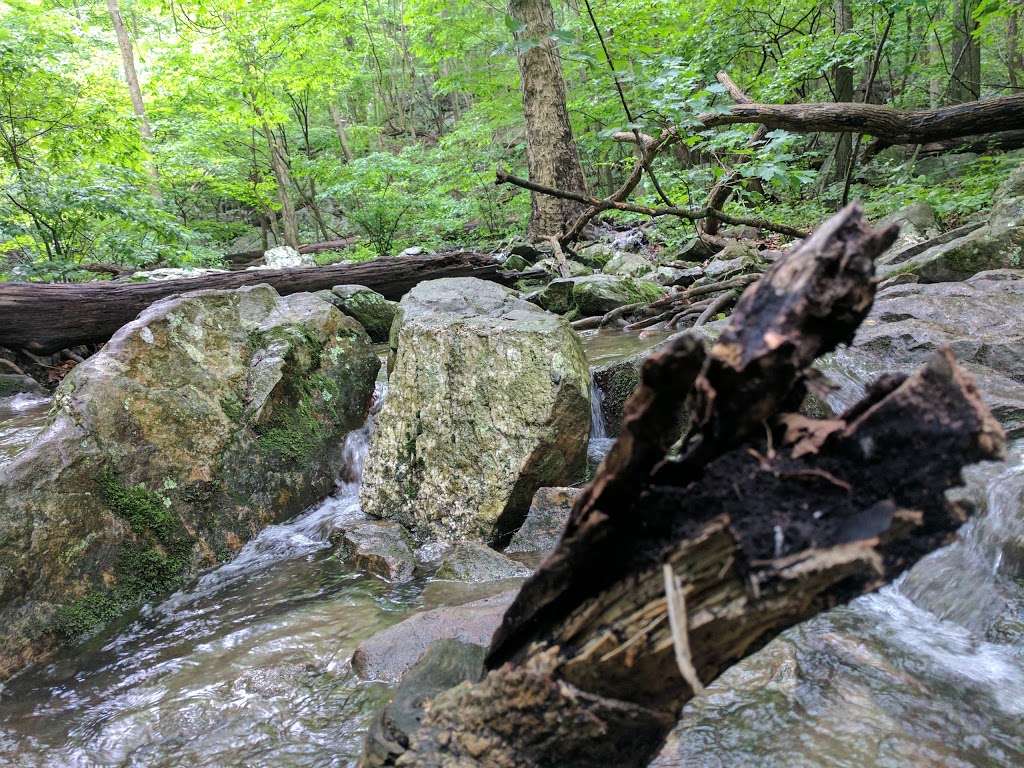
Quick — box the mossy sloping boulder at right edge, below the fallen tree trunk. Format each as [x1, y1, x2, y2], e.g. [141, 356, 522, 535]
[879, 165, 1024, 283]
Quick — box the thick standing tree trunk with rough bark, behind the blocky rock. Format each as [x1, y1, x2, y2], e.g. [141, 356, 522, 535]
[509, 0, 587, 241]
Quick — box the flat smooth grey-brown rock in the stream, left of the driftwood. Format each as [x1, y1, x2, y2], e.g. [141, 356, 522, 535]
[352, 590, 518, 682]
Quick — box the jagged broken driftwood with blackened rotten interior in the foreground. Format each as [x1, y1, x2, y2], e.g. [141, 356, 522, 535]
[372, 206, 1005, 768]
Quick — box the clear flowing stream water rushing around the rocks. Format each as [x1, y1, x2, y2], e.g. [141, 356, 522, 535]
[0, 334, 1024, 768]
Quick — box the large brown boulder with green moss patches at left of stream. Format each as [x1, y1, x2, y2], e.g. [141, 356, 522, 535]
[0, 286, 380, 678]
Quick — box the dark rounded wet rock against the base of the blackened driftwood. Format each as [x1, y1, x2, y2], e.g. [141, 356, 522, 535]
[359, 640, 486, 768]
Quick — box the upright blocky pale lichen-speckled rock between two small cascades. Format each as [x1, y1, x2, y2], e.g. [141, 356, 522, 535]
[360, 278, 590, 541]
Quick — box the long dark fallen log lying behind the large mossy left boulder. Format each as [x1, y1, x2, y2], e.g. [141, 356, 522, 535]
[0, 252, 519, 352]
